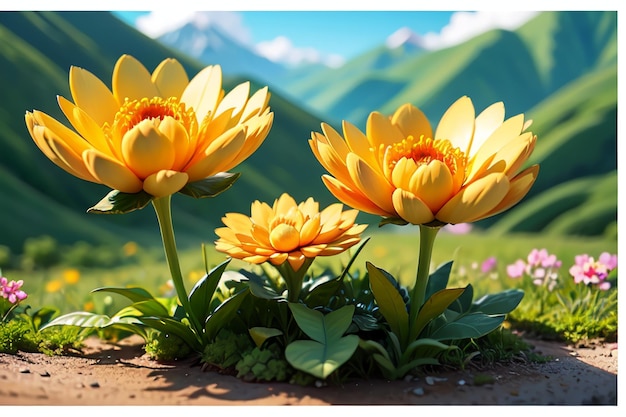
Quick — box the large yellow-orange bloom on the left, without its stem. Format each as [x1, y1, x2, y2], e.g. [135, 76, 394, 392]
[26, 55, 273, 197]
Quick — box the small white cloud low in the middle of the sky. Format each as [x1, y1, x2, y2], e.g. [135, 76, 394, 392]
[254, 36, 344, 67]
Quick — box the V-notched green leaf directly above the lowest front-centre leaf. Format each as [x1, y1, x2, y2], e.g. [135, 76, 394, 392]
[289, 303, 354, 344]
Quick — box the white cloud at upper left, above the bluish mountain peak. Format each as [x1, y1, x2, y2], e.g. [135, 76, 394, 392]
[136, 9, 251, 45]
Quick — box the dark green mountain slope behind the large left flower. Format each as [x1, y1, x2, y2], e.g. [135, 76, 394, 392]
[0, 12, 334, 250]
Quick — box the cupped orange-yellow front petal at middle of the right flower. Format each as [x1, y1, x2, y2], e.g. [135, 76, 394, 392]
[408, 159, 456, 213]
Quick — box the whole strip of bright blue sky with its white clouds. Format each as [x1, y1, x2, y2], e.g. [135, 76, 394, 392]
[113, 7, 533, 66]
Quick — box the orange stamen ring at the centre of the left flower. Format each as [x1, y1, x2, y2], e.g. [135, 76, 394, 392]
[105, 97, 198, 137]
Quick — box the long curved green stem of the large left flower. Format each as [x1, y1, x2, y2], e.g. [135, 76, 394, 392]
[152, 195, 202, 339]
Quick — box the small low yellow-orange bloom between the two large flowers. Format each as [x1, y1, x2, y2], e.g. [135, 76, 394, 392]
[215, 193, 367, 271]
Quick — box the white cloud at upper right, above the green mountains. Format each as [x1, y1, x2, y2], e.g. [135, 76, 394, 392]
[423, 11, 538, 49]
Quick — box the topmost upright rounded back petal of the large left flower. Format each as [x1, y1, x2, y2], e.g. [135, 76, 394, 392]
[113, 55, 159, 104]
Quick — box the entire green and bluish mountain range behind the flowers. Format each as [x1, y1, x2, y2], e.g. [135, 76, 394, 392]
[0, 12, 617, 251]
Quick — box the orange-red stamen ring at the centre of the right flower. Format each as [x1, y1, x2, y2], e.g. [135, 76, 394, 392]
[387, 135, 467, 176]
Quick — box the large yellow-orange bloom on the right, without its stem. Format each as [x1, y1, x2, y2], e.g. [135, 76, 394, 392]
[309, 97, 539, 225]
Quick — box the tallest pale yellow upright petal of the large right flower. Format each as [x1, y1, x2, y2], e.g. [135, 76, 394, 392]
[433, 96, 475, 155]
